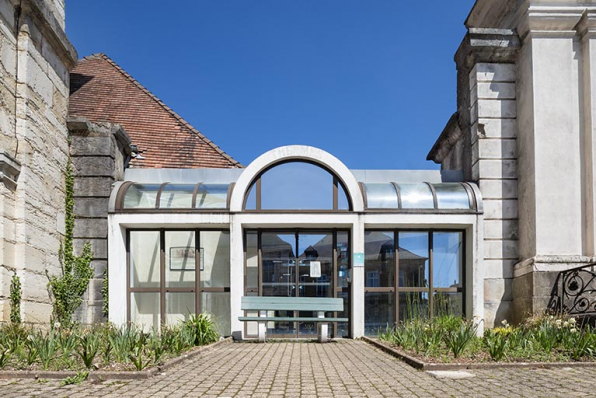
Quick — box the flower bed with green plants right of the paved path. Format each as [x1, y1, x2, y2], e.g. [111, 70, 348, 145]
[379, 316, 596, 364]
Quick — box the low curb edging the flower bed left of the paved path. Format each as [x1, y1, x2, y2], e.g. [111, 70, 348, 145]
[0, 337, 233, 381]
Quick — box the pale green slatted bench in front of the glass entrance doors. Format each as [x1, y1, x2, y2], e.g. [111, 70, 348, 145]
[238, 297, 348, 343]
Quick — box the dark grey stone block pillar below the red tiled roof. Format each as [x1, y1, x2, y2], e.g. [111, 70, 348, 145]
[68, 118, 131, 324]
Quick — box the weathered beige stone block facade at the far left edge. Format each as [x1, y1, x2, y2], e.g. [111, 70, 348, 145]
[0, 0, 76, 322]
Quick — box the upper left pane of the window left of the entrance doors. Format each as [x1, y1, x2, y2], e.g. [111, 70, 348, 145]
[129, 231, 160, 288]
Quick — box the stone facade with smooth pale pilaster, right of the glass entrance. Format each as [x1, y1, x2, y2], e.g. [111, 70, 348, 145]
[429, 0, 596, 325]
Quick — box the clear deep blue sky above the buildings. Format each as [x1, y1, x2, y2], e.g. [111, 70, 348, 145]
[66, 0, 474, 169]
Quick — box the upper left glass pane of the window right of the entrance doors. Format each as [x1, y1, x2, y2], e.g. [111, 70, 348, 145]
[364, 231, 395, 287]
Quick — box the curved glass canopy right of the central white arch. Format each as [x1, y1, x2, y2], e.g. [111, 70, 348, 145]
[363, 182, 475, 210]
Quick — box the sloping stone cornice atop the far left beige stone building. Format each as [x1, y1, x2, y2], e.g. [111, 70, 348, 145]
[11, 0, 78, 69]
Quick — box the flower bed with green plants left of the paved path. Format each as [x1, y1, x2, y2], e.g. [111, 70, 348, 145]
[0, 314, 219, 372]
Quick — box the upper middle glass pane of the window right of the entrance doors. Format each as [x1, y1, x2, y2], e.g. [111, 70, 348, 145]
[398, 232, 429, 287]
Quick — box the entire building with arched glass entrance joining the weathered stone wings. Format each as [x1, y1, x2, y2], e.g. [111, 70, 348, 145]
[0, 0, 596, 332]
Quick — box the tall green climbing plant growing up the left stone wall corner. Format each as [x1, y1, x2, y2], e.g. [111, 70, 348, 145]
[46, 161, 93, 327]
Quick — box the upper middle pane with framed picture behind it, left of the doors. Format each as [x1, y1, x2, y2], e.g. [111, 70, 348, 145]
[165, 231, 196, 287]
